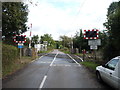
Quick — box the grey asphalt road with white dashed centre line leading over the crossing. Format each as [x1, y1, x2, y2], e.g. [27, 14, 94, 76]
[3, 50, 110, 88]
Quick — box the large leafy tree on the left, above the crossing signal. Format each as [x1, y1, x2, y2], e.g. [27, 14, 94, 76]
[2, 2, 28, 44]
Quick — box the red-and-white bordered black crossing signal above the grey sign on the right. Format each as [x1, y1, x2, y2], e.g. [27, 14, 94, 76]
[84, 29, 99, 39]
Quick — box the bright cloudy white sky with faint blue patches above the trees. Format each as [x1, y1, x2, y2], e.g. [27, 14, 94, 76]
[25, 0, 118, 40]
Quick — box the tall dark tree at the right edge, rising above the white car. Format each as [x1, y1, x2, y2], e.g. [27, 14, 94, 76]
[103, 1, 120, 59]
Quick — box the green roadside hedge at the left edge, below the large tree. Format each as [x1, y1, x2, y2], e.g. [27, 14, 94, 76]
[2, 44, 19, 69]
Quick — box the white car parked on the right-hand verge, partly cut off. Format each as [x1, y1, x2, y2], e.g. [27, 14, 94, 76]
[96, 56, 120, 90]
